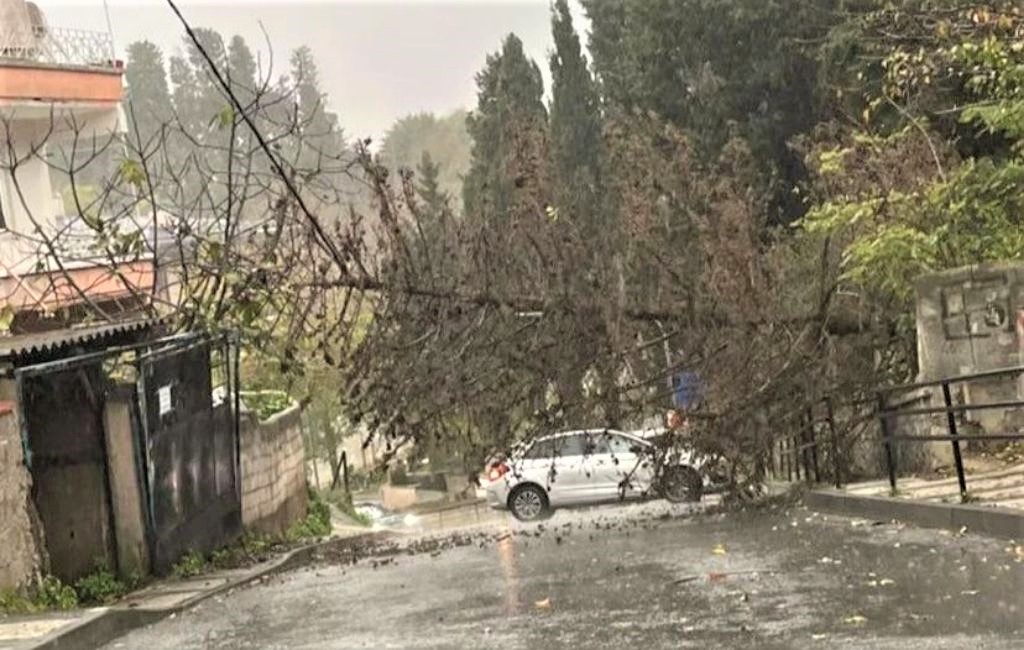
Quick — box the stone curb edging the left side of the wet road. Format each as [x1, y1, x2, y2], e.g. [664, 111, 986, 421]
[32, 532, 388, 650]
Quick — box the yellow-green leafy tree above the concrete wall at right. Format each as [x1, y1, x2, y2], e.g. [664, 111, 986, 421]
[803, 2, 1024, 302]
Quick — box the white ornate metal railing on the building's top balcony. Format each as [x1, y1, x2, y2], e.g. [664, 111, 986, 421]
[0, 25, 117, 68]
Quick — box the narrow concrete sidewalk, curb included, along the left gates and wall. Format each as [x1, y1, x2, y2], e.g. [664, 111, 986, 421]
[0, 528, 388, 650]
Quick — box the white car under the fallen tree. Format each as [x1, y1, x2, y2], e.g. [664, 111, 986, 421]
[486, 429, 705, 521]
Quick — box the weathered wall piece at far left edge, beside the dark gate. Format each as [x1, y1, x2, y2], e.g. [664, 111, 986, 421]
[0, 402, 44, 590]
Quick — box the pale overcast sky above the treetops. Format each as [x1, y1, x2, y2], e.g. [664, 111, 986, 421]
[48, 0, 586, 145]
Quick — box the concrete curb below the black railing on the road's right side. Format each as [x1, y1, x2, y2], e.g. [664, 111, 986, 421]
[804, 490, 1024, 539]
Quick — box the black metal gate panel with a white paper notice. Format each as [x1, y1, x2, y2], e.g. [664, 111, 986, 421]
[136, 337, 242, 572]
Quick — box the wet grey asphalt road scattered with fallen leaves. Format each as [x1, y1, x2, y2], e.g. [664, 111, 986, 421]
[101, 505, 1024, 650]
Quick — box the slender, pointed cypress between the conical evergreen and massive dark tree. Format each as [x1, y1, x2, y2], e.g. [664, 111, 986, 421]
[550, 0, 603, 227]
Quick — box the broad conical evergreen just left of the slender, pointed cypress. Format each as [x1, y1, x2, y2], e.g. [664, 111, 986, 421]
[463, 34, 548, 220]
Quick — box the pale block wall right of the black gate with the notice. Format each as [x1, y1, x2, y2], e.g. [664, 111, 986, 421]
[240, 405, 306, 534]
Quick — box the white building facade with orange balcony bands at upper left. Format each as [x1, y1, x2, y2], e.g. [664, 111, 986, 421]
[0, 0, 154, 333]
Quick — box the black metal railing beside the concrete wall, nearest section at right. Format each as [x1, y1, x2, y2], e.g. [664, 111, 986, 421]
[878, 365, 1024, 503]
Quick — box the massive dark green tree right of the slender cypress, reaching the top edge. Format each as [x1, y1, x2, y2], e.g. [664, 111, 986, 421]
[583, 0, 845, 221]
